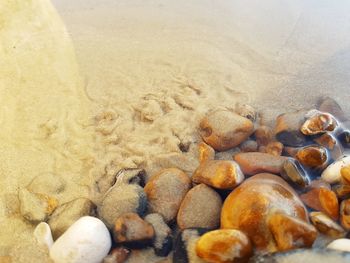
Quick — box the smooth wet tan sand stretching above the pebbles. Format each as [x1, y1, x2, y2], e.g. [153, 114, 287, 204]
[0, 0, 350, 262]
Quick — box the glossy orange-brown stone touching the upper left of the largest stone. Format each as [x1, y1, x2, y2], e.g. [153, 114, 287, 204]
[192, 160, 244, 189]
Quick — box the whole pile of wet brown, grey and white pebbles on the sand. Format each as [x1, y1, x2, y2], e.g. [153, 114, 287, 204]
[28, 98, 350, 263]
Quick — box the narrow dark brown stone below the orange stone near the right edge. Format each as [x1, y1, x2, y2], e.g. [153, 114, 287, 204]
[310, 212, 346, 238]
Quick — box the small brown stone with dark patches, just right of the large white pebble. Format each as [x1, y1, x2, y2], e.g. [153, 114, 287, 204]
[113, 213, 155, 245]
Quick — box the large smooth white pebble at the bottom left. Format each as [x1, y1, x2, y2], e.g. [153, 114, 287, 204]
[50, 216, 111, 263]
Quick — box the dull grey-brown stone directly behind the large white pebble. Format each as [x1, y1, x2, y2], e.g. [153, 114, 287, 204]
[48, 198, 96, 239]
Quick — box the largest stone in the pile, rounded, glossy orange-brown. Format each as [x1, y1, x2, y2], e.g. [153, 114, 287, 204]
[221, 173, 308, 252]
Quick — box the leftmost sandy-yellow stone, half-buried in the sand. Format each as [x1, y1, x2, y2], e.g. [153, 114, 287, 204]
[19, 188, 58, 223]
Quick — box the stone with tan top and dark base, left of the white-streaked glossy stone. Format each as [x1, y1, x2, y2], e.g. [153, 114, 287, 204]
[275, 110, 307, 147]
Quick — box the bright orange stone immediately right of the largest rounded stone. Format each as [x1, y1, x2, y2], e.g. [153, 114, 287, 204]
[300, 187, 339, 220]
